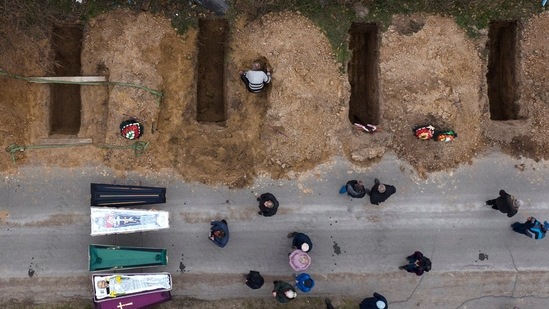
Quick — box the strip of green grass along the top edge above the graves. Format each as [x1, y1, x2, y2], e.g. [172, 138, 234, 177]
[5, 0, 544, 69]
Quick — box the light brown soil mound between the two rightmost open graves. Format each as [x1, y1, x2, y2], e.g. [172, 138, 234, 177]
[380, 16, 485, 176]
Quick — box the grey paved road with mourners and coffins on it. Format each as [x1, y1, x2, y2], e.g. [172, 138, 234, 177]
[0, 153, 549, 309]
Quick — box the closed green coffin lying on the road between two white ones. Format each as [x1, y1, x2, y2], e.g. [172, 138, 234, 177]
[89, 245, 168, 271]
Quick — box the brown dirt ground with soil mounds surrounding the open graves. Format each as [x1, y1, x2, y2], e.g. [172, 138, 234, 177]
[0, 10, 549, 188]
